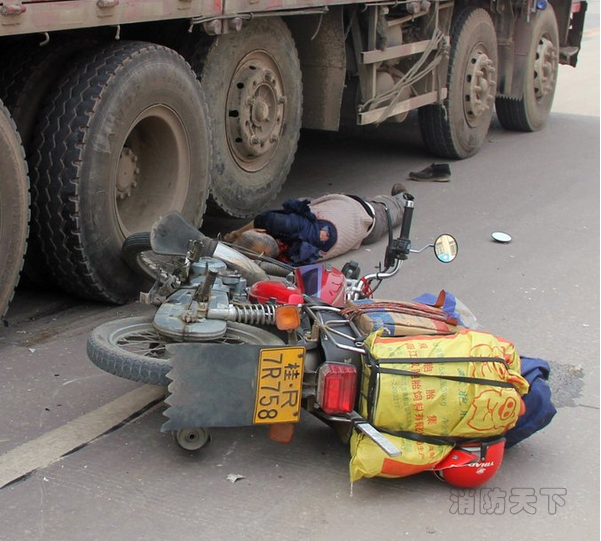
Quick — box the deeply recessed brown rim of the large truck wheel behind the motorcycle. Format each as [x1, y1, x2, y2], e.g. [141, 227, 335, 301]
[115, 105, 191, 237]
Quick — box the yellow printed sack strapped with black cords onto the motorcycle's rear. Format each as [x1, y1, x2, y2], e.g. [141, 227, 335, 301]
[351, 330, 528, 479]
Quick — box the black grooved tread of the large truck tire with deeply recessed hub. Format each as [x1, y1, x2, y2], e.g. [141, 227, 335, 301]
[32, 42, 210, 304]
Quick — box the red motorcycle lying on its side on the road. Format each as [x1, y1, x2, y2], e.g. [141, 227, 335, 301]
[87, 196, 519, 486]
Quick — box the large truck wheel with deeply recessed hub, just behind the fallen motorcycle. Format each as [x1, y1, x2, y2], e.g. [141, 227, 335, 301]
[32, 42, 210, 303]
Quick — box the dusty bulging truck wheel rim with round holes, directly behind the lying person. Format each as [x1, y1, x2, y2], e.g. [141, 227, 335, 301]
[226, 51, 286, 172]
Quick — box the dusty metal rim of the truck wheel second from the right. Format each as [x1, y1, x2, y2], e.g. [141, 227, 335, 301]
[463, 44, 497, 127]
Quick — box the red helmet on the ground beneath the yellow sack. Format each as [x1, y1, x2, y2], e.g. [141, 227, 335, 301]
[434, 438, 505, 488]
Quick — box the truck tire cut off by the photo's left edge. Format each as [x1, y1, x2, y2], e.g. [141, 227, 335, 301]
[0, 102, 29, 317]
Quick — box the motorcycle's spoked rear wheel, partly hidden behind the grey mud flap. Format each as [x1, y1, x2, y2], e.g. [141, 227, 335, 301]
[87, 317, 284, 387]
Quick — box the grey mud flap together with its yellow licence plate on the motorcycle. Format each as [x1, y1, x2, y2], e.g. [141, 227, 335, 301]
[161, 343, 304, 432]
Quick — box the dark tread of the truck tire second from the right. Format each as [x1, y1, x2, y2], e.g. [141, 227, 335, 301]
[418, 6, 494, 160]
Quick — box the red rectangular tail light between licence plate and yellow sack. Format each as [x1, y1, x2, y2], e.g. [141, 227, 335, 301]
[316, 363, 357, 415]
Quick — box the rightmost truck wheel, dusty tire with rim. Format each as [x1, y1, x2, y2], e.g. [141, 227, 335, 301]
[496, 8, 559, 132]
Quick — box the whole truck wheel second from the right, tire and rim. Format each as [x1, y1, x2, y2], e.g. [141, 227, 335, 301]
[419, 7, 497, 159]
